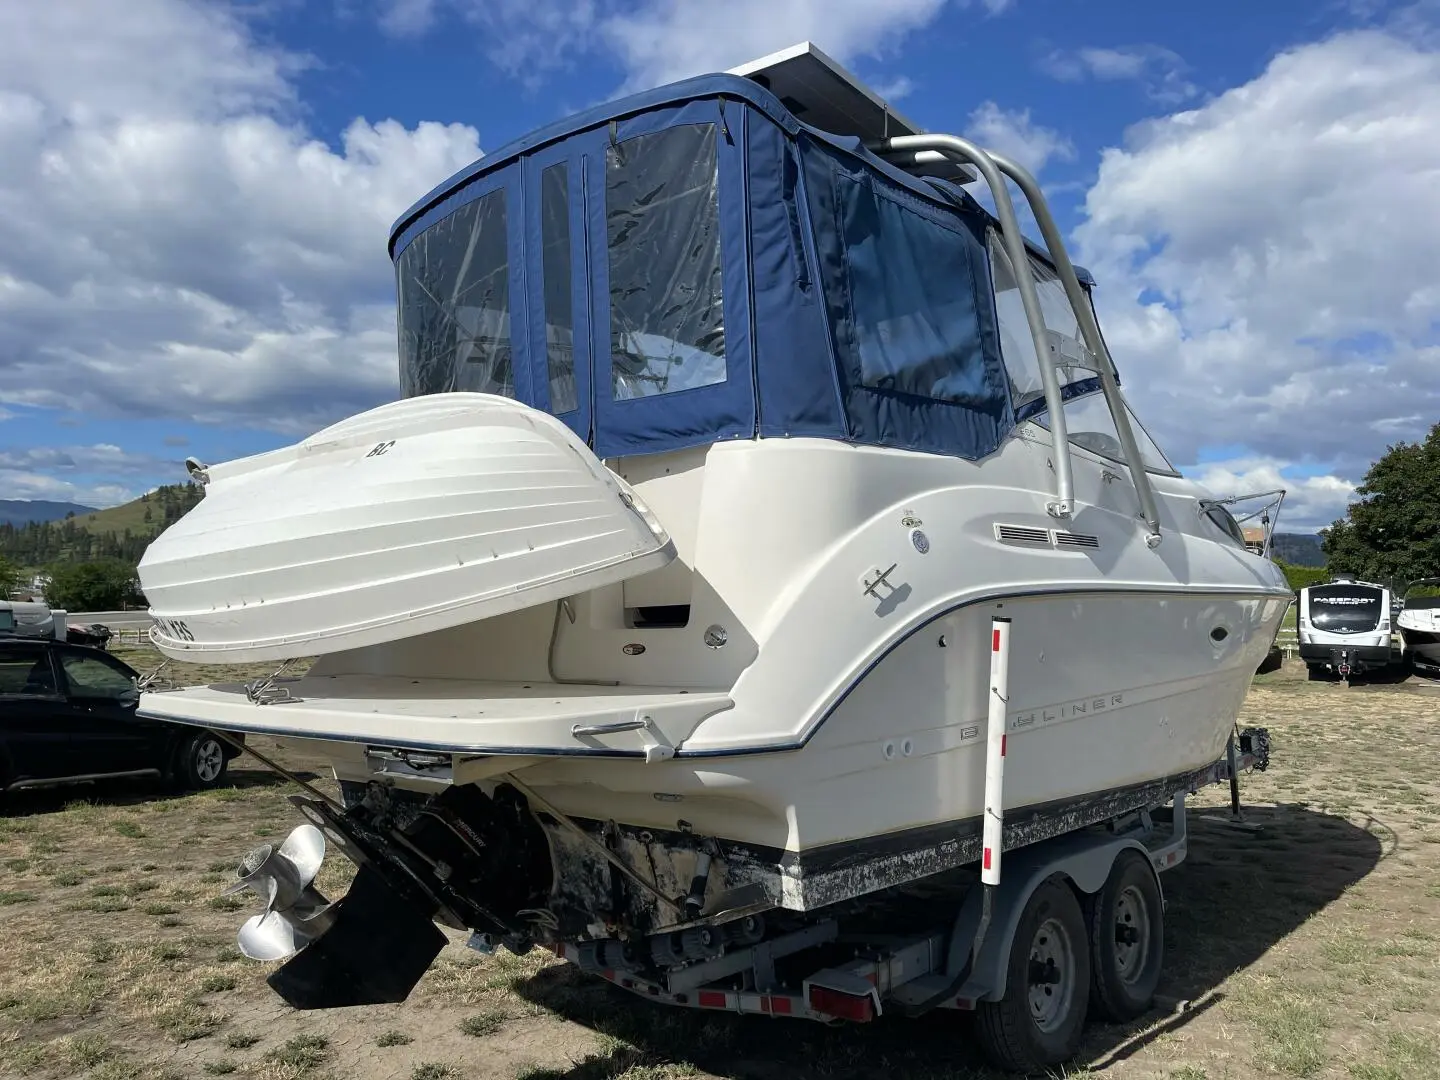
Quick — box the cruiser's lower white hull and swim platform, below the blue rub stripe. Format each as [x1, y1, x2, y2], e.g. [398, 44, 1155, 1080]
[143, 590, 1286, 910]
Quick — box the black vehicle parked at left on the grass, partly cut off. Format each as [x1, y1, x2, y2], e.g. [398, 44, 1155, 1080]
[0, 634, 240, 792]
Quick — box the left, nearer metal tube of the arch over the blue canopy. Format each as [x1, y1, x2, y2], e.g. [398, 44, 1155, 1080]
[867, 135, 1076, 517]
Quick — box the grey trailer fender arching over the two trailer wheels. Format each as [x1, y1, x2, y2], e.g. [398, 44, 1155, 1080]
[946, 835, 1165, 1002]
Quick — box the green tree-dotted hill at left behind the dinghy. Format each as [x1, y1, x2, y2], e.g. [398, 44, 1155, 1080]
[0, 482, 204, 569]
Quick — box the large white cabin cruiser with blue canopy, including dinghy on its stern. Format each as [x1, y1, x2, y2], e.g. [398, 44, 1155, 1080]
[140, 46, 1290, 1059]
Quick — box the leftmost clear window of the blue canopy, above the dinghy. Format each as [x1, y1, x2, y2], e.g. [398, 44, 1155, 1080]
[396, 190, 516, 397]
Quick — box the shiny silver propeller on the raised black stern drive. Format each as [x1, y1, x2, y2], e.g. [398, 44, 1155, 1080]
[223, 825, 336, 960]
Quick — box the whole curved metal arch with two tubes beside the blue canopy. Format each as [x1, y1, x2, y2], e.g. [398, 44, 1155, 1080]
[871, 135, 1161, 547]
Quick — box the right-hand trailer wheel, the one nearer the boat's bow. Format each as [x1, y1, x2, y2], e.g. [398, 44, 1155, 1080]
[1090, 850, 1165, 1024]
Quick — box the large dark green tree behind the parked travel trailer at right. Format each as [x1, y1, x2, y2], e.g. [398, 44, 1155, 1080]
[1320, 423, 1440, 593]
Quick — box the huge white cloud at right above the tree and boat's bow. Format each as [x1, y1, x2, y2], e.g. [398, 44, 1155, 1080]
[1076, 32, 1440, 504]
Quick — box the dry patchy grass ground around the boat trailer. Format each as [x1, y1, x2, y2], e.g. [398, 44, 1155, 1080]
[0, 651, 1440, 1080]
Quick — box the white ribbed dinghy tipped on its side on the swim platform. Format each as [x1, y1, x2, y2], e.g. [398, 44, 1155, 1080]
[144, 393, 675, 664]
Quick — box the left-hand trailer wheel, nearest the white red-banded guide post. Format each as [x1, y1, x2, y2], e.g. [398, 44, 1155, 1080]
[975, 878, 1090, 1073]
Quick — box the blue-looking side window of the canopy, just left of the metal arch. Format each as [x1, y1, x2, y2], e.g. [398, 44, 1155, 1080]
[837, 179, 991, 402]
